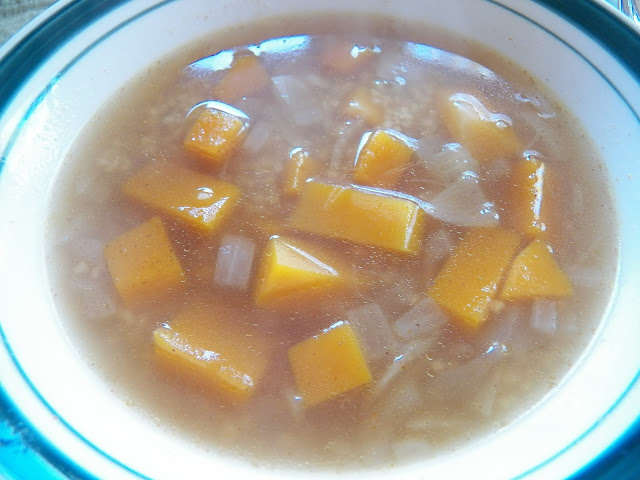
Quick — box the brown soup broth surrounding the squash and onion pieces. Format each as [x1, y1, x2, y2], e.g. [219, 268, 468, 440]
[49, 17, 617, 468]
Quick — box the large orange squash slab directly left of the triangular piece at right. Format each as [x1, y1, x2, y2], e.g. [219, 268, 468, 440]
[428, 228, 520, 328]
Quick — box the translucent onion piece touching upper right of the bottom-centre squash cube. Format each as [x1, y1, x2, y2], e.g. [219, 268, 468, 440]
[347, 302, 398, 361]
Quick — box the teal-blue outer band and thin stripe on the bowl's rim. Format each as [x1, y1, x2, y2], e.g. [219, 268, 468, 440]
[0, 0, 640, 480]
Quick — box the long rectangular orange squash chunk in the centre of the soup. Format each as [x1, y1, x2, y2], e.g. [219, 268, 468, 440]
[290, 181, 426, 254]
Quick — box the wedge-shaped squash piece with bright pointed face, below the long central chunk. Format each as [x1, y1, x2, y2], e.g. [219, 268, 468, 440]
[255, 236, 349, 309]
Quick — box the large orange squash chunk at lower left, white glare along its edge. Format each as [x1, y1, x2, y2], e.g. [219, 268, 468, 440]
[153, 303, 272, 401]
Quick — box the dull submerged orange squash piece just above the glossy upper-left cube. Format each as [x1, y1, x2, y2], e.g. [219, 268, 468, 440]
[213, 52, 271, 102]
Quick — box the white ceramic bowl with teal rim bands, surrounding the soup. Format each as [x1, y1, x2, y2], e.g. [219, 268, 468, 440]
[0, 0, 640, 479]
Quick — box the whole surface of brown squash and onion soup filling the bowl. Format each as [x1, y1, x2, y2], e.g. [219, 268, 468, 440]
[49, 17, 616, 468]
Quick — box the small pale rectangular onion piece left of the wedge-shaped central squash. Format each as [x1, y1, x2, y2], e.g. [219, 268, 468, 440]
[213, 235, 255, 289]
